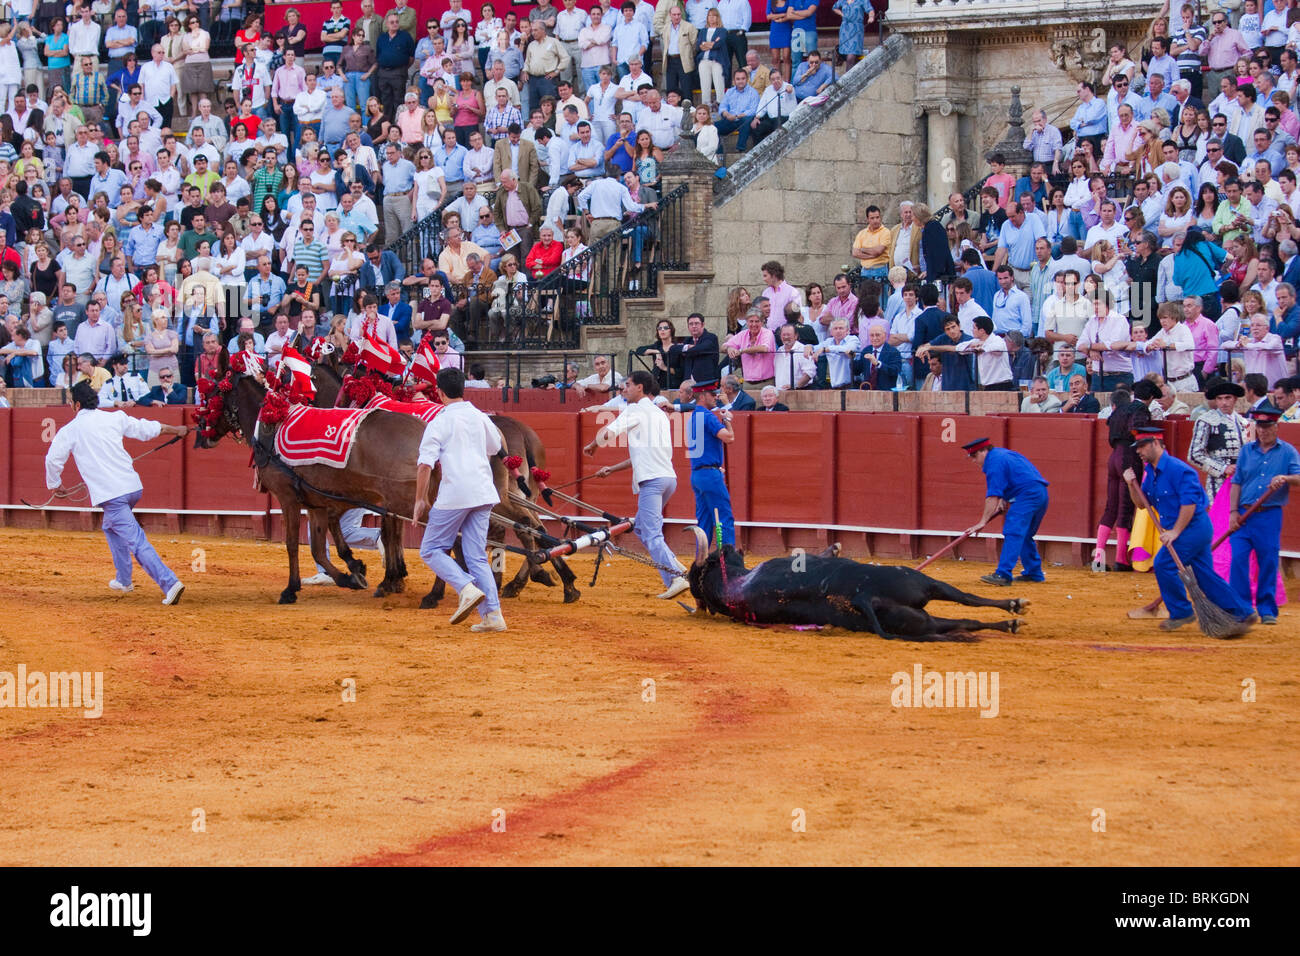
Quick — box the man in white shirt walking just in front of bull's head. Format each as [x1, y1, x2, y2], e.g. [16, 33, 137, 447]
[585, 368, 690, 600]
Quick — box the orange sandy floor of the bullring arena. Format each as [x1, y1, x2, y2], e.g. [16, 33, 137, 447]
[0, 529, 1300, 865]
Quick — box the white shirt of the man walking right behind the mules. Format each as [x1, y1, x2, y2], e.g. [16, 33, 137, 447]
[417, 402, 501, 511]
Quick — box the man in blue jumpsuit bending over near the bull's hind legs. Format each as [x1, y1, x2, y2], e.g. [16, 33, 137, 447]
[962, 438, 1048, 587]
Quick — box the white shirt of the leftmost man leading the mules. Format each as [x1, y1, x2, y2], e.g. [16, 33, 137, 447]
[46, 408, 163, 505]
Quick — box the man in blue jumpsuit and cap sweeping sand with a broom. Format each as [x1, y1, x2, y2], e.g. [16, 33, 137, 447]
[1125, 425, 1258, 637]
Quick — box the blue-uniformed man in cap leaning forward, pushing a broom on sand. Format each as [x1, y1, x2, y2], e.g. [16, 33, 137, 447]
[1123, 425, 1255, 631]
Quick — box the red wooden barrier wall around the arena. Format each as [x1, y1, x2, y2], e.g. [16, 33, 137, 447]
[0, 411, 1300, 561]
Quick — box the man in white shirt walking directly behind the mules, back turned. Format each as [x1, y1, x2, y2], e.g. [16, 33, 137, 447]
[415, 368, 506, 631]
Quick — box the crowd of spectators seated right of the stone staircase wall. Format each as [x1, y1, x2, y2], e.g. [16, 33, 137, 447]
[616, 0, 1300, 420]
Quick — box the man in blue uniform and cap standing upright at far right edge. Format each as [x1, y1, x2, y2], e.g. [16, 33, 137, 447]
[1227, 401, 1300, 624]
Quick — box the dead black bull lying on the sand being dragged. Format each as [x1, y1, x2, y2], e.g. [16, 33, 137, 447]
[688, 527, 1030, 641]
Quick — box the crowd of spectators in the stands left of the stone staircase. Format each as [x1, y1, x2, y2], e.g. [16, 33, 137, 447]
[0, 0, 875, 392]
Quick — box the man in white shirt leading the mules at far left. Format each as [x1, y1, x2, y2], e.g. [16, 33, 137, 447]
[46, 381, 190, 605]
